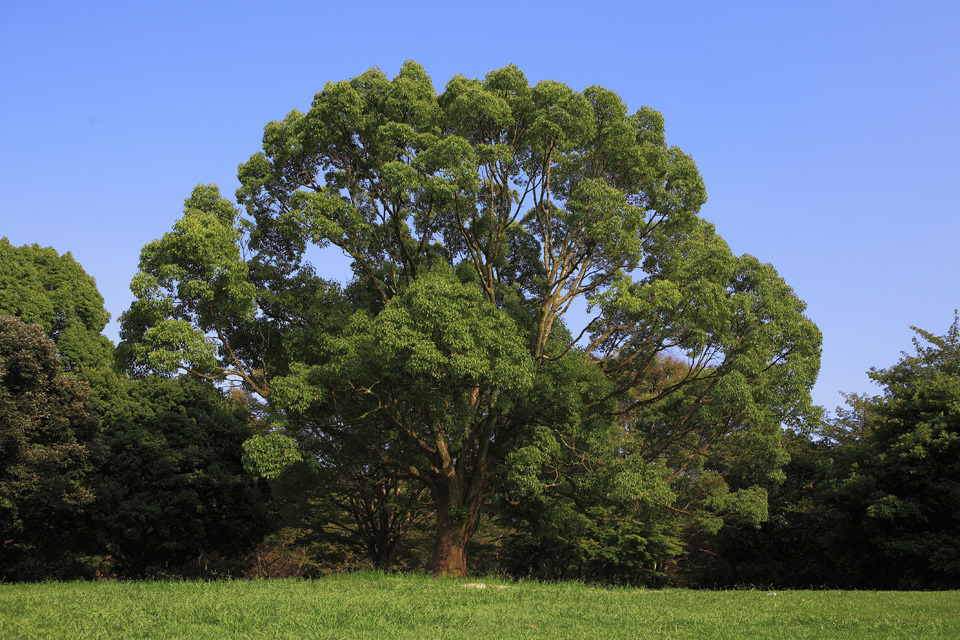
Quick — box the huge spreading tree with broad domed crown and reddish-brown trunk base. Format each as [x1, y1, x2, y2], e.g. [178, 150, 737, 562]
[121, 63, 820, 574]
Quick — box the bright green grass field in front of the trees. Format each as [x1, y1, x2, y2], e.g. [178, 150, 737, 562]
[0, 573, 960, 640]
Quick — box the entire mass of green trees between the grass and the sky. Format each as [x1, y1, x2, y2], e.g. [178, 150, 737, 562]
[0, 63, 960, 589]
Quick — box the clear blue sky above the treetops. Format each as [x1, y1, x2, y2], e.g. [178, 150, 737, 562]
[0, 0, 960, 416]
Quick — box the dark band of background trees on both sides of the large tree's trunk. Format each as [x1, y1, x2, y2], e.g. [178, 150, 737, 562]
[0, 260, 960, 589]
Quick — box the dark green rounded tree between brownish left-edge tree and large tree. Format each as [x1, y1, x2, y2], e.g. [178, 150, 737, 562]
[88, 377, 267, 577]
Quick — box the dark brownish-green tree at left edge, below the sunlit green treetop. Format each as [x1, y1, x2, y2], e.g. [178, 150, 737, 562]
[0, 315, 101, 580]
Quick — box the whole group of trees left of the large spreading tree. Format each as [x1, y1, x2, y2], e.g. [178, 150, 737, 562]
[0, 248, 268, 580]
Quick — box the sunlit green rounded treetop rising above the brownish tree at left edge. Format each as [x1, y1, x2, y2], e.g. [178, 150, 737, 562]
[0, 238, 113, 373]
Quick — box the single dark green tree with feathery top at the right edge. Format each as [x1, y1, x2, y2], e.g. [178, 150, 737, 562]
[828, 317, 960, 588]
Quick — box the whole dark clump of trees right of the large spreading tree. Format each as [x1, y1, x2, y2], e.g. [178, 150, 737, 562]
[703, 319, 960, 589]
